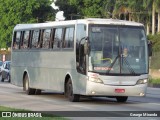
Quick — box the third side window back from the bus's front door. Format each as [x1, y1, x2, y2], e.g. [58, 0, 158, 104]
[42, 29, 51, 49]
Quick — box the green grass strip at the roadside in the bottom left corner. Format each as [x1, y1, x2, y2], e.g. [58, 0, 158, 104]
[0, 106, 68, 120]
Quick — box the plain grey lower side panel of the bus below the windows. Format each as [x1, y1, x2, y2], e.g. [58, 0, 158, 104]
[11, 50, 86, 94]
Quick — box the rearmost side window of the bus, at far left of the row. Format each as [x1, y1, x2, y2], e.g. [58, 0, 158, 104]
[13, 32, 21, 49]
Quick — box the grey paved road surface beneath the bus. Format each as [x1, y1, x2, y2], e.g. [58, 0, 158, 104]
[0, 82, 160, 120]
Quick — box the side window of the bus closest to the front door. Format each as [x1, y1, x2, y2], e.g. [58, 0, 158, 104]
[63, 27, 74, 48]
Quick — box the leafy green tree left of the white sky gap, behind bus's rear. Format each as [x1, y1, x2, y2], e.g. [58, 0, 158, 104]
[0, 0, 55, 48]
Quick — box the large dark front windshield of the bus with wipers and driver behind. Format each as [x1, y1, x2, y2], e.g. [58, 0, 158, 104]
[89, 25, 148, 75]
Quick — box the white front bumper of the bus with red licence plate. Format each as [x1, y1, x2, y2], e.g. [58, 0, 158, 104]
[86, 81, 147, 96]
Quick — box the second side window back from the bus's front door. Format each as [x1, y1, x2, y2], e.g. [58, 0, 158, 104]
[53, 28, 62, 49]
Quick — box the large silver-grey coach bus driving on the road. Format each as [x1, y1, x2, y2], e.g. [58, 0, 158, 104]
[11, 18, 149, 102]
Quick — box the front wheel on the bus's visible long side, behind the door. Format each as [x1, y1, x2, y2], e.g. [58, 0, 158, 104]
[65, 79, 80, 102]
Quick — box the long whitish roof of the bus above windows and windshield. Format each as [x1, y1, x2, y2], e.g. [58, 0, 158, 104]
[14, 18, 143, 30]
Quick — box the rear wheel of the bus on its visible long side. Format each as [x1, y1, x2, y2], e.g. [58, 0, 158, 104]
[24, 75, 36, 95]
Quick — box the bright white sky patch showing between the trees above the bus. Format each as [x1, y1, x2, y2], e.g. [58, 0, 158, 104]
[51, 0, 65, 21]
